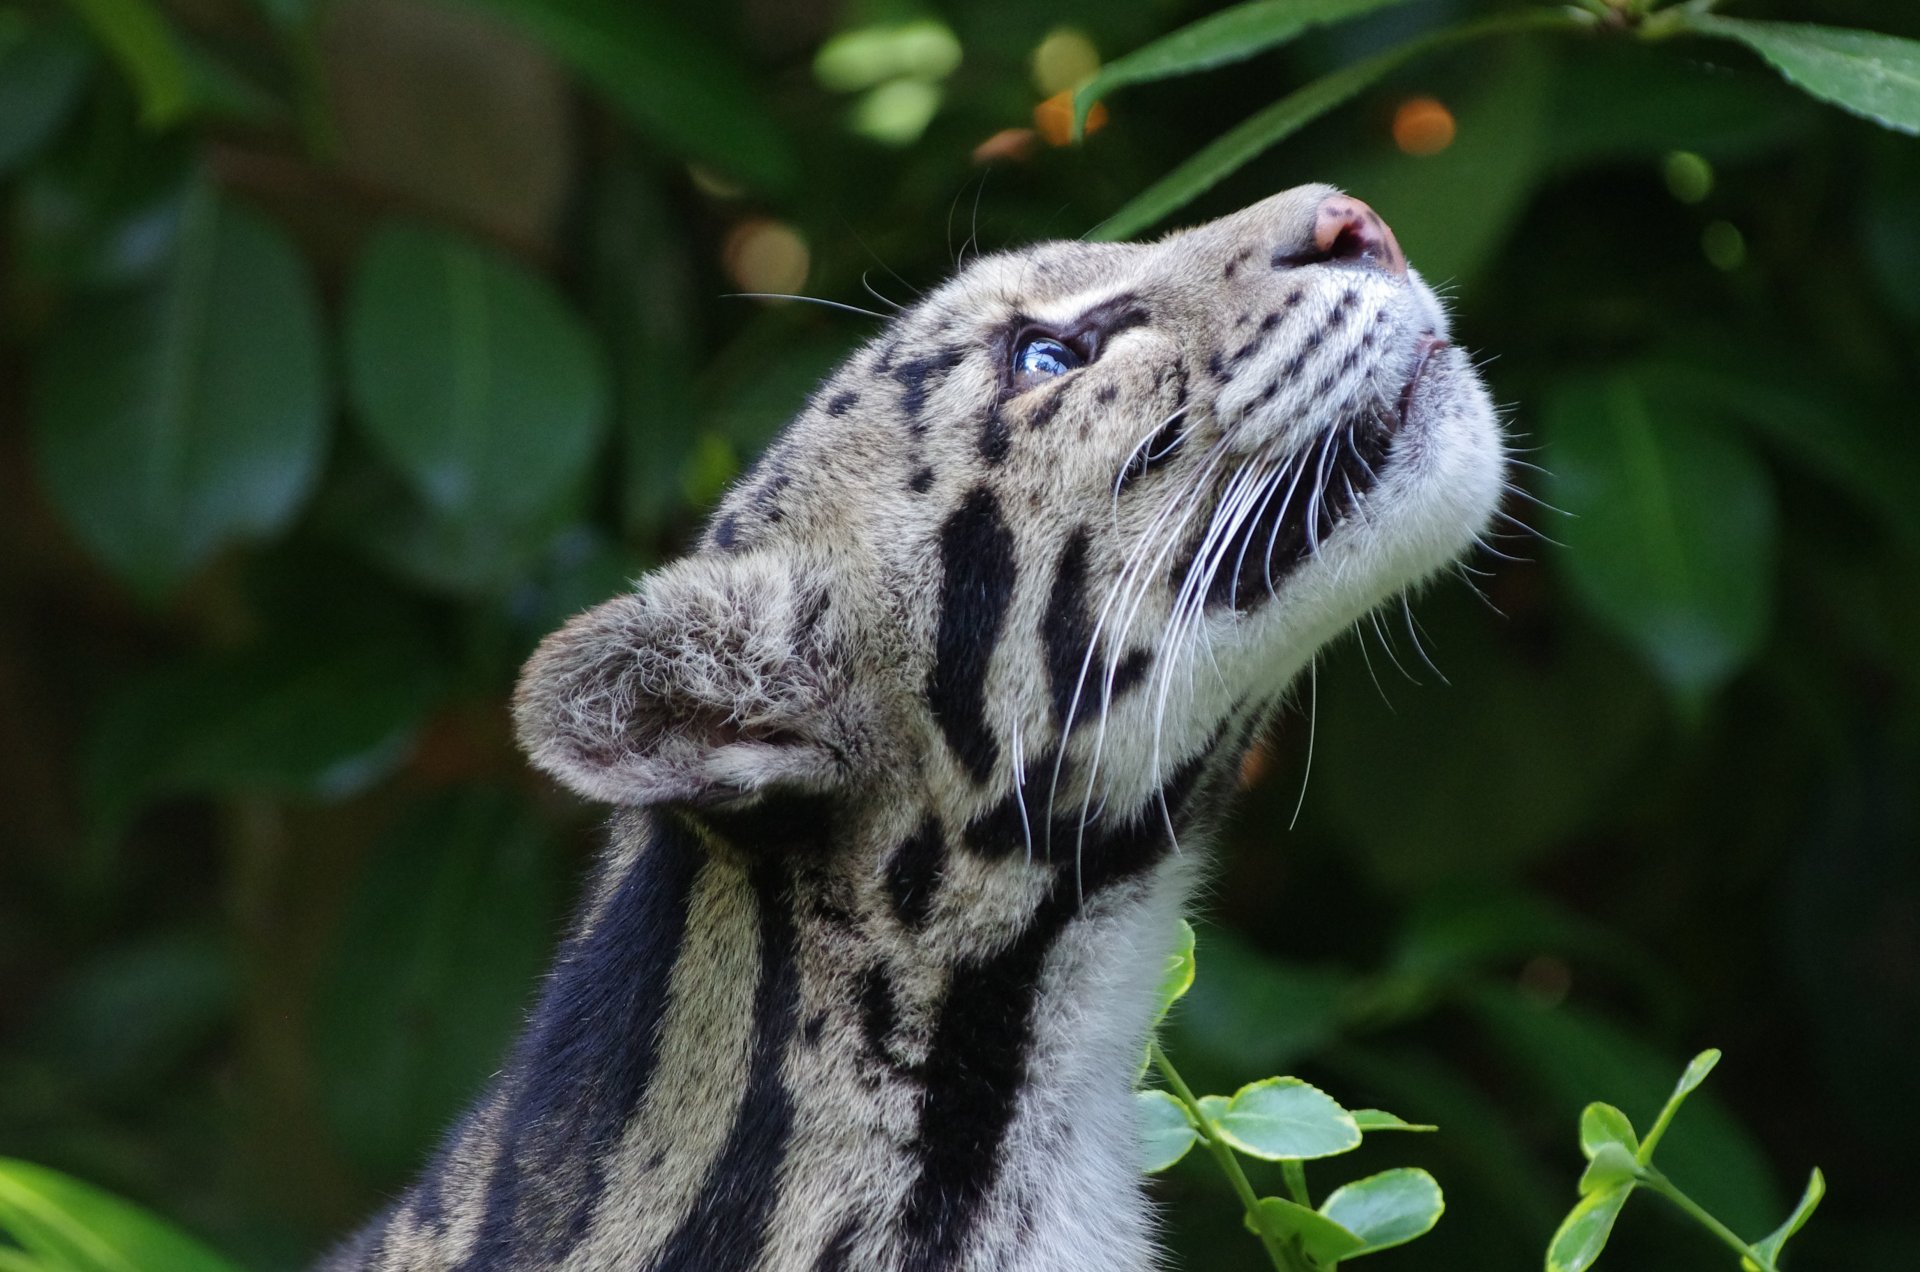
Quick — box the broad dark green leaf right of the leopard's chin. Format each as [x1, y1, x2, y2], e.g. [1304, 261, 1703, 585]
[1544, 375, 1776, 707]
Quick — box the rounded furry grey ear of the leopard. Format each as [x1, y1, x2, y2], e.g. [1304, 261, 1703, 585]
[513, 555, 862, 805]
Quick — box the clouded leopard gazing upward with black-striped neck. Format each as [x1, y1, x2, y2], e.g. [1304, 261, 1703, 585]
[326, 186, 1503, 1272]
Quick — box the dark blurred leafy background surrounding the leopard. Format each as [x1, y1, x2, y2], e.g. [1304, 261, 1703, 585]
[0, 0, 1920, 1272]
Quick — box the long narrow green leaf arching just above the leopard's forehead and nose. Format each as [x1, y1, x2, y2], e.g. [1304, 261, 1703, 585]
[1087, 10, 1565, 240]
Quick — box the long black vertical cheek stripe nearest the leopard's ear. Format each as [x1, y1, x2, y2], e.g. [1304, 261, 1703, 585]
[927, 486, 1016, 782]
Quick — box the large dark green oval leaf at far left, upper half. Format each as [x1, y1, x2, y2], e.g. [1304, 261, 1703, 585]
[33, 186, 330, 598]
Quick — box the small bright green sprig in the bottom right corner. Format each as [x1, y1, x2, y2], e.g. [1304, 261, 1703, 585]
[1546, 1051, 1826, 1272]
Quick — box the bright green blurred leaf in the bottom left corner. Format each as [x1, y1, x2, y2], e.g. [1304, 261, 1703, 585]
[0, 1157, 238, 1272]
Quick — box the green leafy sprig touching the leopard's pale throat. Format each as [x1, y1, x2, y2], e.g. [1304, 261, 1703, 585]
[1135, 922, 1446, 1272]
